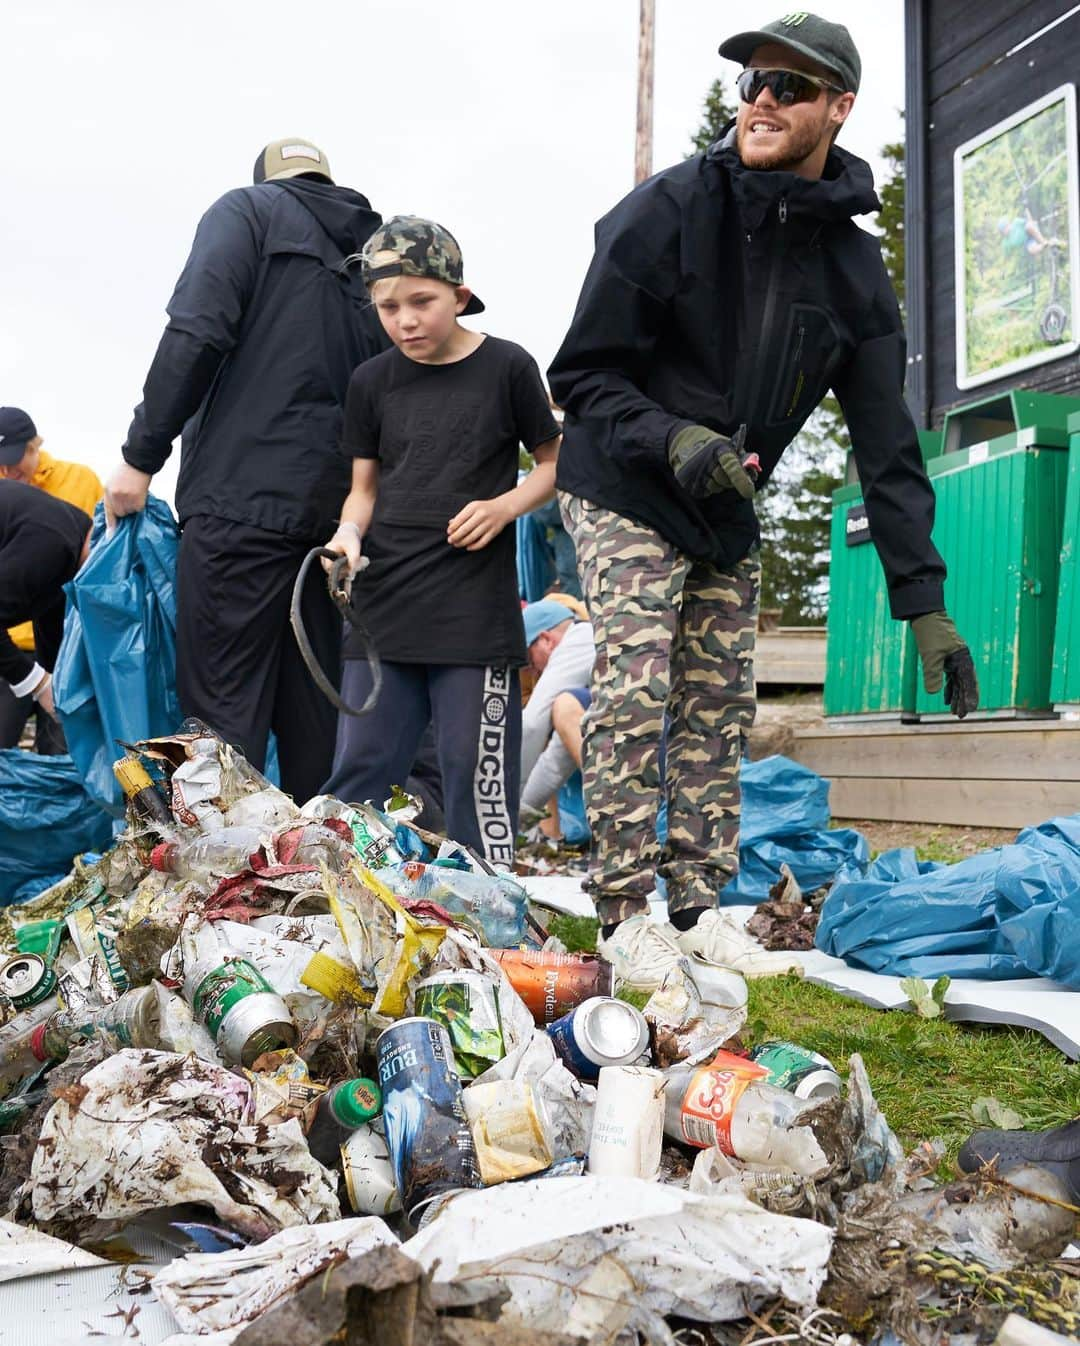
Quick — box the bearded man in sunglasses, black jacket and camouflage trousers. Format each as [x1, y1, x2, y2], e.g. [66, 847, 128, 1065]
[549, 12, 978, 938]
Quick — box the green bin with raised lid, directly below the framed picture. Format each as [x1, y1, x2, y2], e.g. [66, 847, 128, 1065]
[916, 422, 1076, 719]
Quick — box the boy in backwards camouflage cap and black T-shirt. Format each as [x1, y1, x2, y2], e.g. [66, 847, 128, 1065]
[326, 215, 559, 865]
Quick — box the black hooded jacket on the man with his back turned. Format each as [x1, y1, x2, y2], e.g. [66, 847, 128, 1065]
[124, 178, 388, 540]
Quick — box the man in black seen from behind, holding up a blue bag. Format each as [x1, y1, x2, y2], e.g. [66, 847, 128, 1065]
[105, 139, 385, 800]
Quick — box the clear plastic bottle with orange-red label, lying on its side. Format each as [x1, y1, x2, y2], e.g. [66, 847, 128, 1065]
[664, 1051, 828, 1178]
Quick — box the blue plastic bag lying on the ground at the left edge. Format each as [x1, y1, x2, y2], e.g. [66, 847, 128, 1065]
[0, 748, 112, 906]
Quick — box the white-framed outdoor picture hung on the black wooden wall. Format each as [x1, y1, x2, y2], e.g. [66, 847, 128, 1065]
[953, 85, 1080, 388]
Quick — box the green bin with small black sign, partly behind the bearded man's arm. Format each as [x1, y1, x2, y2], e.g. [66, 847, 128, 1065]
[824, 485, 916, 719]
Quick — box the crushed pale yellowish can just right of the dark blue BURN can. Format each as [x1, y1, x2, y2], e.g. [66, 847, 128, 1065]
[465, 1079, 552, 1187]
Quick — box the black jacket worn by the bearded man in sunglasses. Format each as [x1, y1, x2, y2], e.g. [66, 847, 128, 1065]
[549, 133, 945, 618]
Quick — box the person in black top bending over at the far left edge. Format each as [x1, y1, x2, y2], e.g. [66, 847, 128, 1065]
[0, 481, 90, 752]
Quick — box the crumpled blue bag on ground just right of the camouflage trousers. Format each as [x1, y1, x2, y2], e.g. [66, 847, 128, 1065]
[720, 756, 870, 903]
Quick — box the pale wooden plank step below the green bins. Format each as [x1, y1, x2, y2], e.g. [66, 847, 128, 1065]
[792, 720, 1080, 828]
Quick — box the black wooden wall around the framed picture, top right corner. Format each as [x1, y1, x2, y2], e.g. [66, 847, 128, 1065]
[899, 0, 1080, 428]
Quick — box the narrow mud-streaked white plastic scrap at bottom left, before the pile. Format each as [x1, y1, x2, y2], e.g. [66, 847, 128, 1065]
[151, 1215, 397, 1339]
